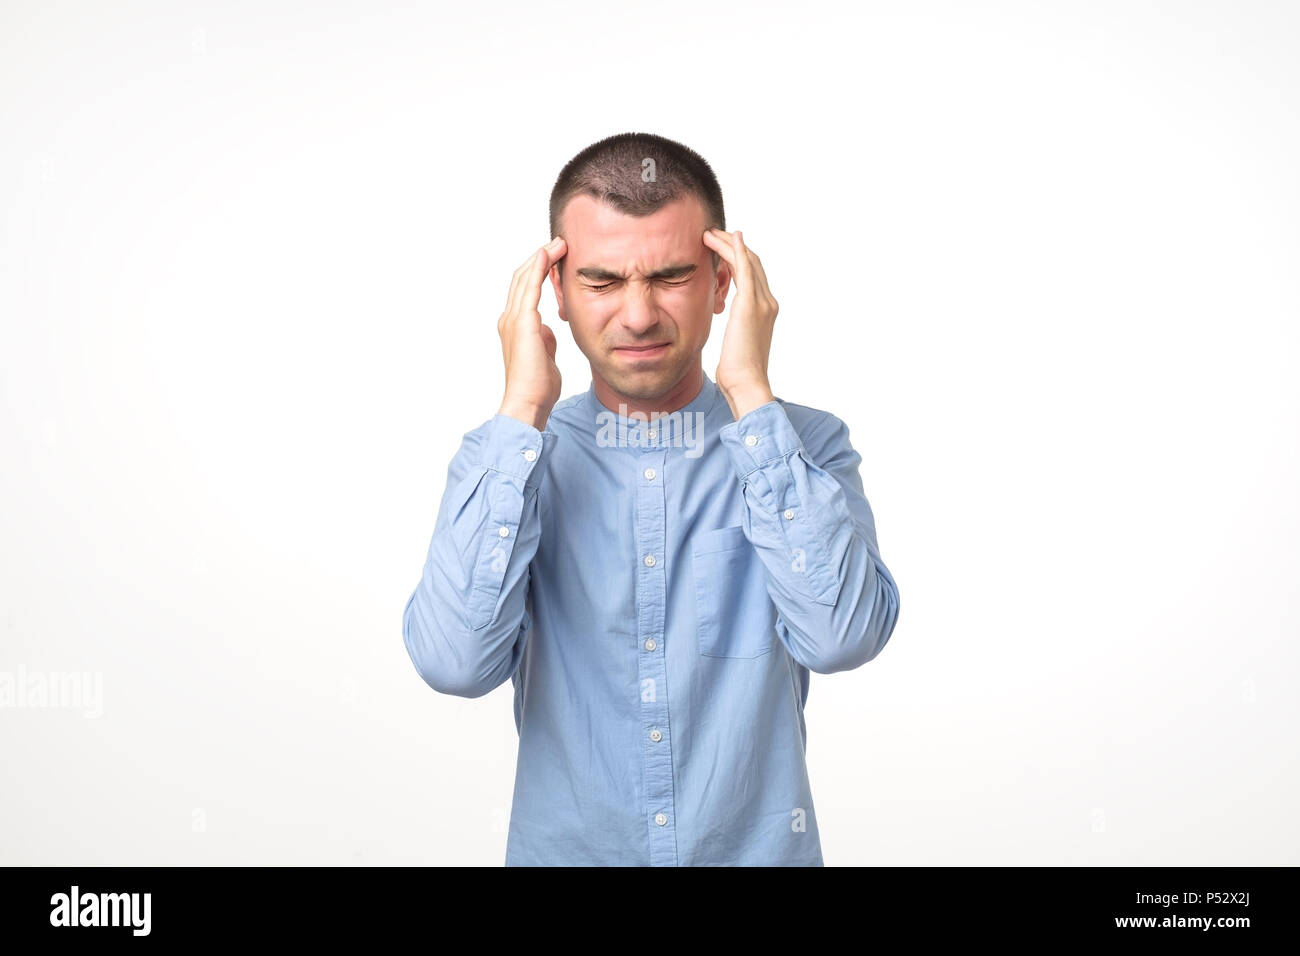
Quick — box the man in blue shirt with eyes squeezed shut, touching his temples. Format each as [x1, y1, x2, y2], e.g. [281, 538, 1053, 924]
[403, 134, 898, 866]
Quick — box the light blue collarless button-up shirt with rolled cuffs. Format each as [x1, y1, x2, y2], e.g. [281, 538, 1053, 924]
[403, 375, 898, 866]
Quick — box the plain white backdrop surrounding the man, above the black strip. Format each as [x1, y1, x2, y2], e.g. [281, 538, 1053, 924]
[0, 0, 1300, 866]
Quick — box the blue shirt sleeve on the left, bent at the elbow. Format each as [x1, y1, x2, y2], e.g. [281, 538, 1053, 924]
[402, 408, 555, 697]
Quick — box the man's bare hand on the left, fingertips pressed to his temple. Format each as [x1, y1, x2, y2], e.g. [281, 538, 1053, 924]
[497, 235, 567, 431]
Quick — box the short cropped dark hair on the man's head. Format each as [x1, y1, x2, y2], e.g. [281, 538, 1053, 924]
[549, 133, 727, 269]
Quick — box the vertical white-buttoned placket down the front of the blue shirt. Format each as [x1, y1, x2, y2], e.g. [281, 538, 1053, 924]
[629, 450, 677, 866]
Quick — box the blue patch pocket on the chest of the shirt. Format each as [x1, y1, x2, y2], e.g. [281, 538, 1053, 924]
[690, 525, 776, 659]
